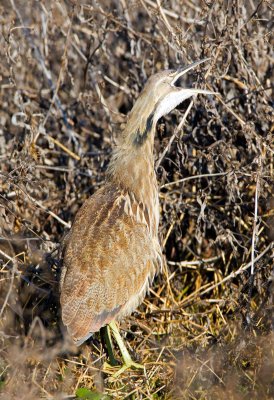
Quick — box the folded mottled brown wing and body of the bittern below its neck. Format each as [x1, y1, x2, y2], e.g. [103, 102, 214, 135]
[60, 186, 161, 344]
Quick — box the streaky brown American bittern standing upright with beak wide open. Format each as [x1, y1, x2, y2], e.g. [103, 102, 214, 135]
[58, 60, 210, 372]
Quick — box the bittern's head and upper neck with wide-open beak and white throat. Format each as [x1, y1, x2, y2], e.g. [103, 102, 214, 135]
[125, 58, 212, 146]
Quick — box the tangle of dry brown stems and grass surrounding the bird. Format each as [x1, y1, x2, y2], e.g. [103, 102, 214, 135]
[0, 0, 274, 400]
